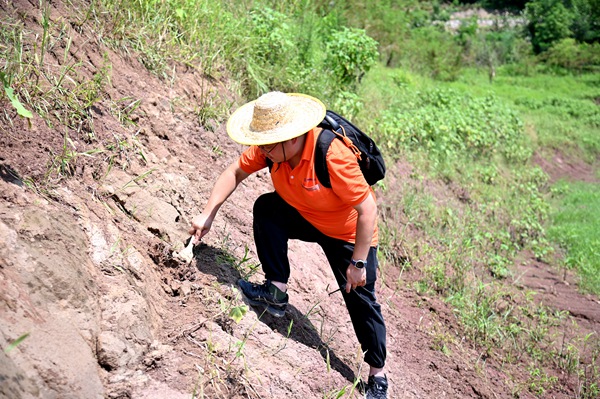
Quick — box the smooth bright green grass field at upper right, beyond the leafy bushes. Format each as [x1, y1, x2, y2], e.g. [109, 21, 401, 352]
[449, 67, 600, 161]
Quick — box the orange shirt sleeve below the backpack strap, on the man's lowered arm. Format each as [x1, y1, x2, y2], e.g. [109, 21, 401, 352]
[327, 139, 371, 207]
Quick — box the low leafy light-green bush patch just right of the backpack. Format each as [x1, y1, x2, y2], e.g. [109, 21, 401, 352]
[376, 89, 531, 162]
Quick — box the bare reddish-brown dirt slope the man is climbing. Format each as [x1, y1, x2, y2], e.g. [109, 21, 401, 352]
[0, 1, 600, 399]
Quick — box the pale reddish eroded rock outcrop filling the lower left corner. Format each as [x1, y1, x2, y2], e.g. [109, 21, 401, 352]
[0, 180, 164, 398]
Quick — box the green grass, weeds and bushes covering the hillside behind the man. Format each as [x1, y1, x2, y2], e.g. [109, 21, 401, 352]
[0, 0, 600, 398]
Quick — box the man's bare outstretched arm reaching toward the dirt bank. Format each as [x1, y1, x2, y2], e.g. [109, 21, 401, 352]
[189, 160, 250, 244]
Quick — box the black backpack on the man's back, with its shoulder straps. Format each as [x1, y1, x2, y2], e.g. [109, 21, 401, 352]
[267, 110, 385, 188]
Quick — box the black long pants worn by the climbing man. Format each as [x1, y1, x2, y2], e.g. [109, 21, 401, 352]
[254, 192, 386, 368]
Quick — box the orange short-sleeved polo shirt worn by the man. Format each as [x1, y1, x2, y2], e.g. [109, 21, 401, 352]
[239, 128, 378, 246]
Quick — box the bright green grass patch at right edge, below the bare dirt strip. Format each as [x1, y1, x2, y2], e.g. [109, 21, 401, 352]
[548, 182, 600, 295]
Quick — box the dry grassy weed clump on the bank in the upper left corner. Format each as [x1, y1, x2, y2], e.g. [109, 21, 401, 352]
[0, 0, 110, 142]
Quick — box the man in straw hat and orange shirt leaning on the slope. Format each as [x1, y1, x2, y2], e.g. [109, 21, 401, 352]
[190, 92, 388, 399]
